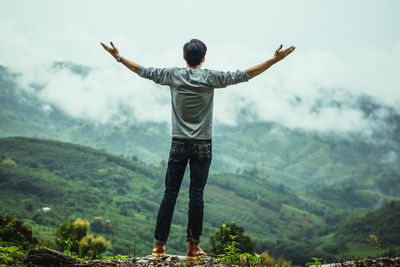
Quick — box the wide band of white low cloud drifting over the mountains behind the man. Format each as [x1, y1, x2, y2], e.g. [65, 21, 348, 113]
[0, 20, 400, 148]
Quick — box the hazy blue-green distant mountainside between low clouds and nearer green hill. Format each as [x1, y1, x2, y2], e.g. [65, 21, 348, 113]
[0, 62, 400, 197]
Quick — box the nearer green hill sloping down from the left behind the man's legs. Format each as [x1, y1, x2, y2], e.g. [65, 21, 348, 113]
[0, 137, 324, 262]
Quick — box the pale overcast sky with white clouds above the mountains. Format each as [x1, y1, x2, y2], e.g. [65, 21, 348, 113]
[0, 0, 400, 140]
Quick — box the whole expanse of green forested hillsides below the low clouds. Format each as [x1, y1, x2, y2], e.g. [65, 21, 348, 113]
[0, 62, 400, 261]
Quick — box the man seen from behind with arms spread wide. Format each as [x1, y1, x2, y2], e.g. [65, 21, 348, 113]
[101, 39, 295, 259]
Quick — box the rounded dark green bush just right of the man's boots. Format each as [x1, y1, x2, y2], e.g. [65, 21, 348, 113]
[210, 222, 255, 255]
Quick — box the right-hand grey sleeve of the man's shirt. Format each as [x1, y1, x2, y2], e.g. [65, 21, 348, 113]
[207, 70, 252, 88]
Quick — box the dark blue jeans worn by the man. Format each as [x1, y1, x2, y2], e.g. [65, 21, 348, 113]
[154, 138, 212, 244]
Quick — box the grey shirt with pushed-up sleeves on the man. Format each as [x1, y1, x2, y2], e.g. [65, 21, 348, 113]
[138, 66, 251, 140]
